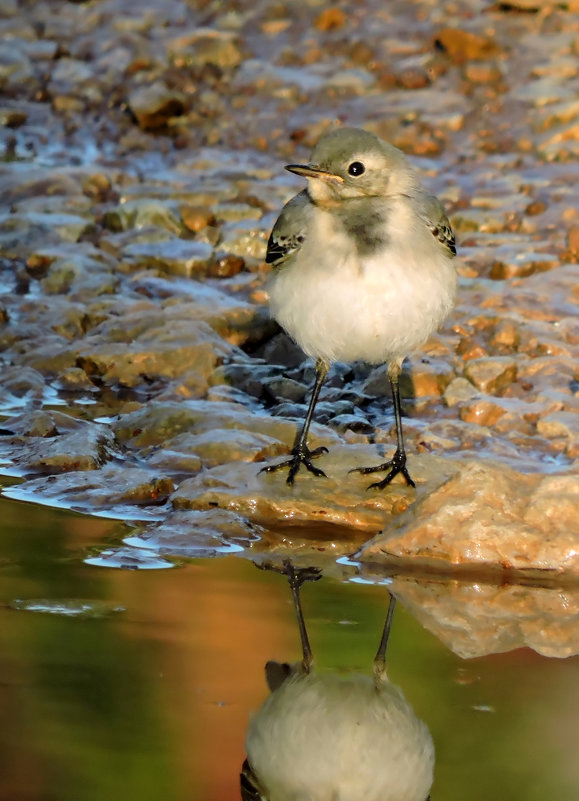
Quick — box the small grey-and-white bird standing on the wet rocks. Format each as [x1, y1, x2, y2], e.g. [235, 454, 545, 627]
[260, 127, 457, 489]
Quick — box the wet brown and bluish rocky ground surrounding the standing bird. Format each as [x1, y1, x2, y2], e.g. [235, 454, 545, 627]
[0, 0, 579, 577]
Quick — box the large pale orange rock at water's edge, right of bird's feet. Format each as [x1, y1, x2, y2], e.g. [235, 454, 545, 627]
[356, 461, 579, 576]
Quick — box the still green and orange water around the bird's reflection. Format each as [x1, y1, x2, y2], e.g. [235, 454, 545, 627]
[0, 490, 579, 801]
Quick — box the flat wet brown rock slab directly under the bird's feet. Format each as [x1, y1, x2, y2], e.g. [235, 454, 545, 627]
[172, 445, 456, 536]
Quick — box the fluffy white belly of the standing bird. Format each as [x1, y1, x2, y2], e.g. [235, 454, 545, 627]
[268, 240, 456, 364]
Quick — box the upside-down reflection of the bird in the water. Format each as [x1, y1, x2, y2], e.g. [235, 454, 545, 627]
[240, 560, 434, 801]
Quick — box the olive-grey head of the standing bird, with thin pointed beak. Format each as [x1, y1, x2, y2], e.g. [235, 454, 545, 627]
[286, 128, 416, 206]
